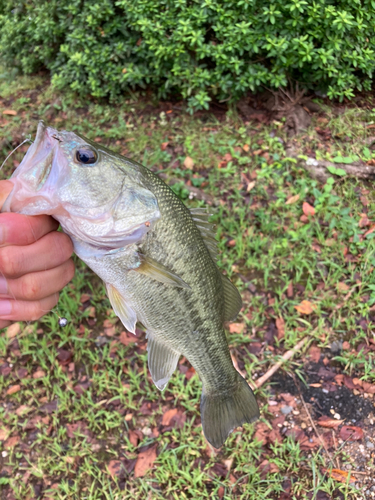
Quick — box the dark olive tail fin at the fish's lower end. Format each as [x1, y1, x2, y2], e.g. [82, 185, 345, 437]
[201, 373, 259, 448]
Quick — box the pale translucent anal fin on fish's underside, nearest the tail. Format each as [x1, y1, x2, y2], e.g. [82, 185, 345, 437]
[147, 332, 180, 391]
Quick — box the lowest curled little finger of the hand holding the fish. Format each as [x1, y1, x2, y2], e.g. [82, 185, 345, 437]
[0, 293, 59, 321]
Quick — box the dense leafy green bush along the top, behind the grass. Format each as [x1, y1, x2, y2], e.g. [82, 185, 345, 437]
[0, 0, 375, 109]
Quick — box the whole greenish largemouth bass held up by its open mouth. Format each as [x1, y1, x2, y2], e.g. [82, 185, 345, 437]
[2, 122, 259, 448]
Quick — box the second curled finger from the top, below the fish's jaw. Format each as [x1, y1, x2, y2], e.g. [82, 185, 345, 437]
[0, 231, 73, 279]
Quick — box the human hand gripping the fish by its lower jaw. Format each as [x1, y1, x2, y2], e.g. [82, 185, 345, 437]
[0, 181, 74, 328]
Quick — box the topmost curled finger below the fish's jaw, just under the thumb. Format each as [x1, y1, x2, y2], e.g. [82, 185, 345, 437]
[0, 213, 59, 246]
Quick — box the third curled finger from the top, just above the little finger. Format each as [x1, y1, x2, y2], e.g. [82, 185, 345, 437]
[0, 259, 74, 301]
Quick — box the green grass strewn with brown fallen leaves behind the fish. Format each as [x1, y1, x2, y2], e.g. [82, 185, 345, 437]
[0, 68, 375, 500]
